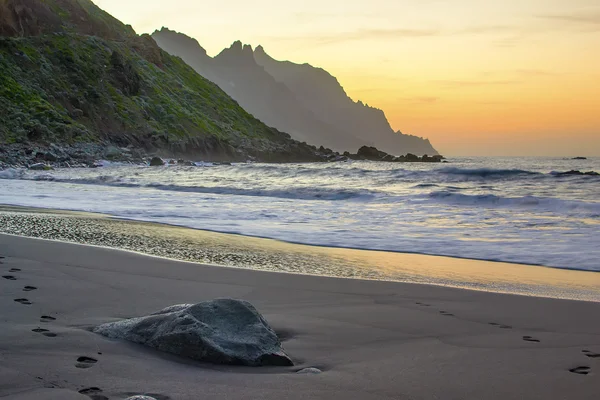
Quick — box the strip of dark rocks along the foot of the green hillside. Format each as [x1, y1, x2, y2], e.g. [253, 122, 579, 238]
[0, 143, 444, 170]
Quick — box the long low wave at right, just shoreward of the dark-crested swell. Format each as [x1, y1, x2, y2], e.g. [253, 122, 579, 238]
[429, 191, 600, 217]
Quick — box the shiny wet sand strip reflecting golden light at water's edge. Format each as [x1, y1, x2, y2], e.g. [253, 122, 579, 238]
[0, 206, 600, 302]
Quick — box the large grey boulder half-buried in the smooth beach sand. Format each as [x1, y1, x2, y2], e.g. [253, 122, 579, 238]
[94, 299, 294, 366]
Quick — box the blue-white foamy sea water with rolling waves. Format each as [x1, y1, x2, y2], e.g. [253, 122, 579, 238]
[0, 157, 600, 271]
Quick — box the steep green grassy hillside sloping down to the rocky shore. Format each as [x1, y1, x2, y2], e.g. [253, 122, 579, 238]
[0, 0, 332, 161]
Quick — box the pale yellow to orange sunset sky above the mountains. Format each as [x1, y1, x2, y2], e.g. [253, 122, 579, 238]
[95, 0, 600, 156]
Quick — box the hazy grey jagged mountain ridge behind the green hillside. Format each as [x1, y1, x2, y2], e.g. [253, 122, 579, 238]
[152, 28, 438, 155]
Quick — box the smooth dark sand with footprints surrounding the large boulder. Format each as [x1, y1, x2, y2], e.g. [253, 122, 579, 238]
[0, 235, 600, 400]
